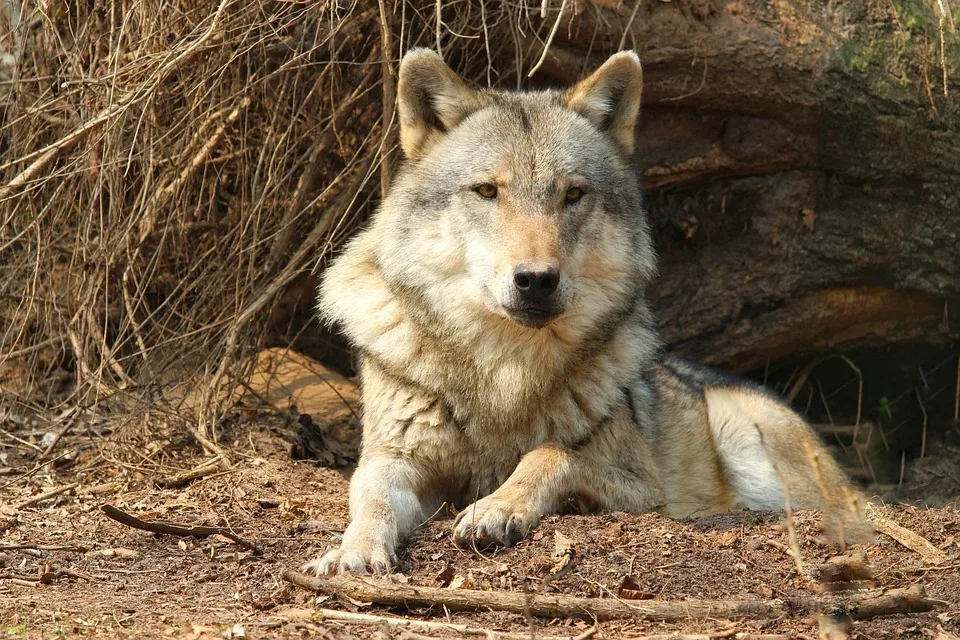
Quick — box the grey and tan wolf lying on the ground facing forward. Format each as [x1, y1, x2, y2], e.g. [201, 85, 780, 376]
[304, 49, 855, 574]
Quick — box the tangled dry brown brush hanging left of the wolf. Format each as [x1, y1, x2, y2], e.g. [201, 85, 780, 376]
[0, 0, 629, 450]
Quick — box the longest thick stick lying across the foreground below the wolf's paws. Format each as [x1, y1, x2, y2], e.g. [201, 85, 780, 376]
[282, 569, 937, 622]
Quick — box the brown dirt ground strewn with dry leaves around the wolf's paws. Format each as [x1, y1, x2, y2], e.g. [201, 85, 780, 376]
[0, 419, 960, 640]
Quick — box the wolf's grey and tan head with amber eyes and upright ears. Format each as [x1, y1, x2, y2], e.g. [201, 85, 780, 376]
[326, 49, 655, 350]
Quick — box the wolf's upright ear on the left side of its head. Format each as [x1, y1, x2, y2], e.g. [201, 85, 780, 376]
[397, 49, 483, 160]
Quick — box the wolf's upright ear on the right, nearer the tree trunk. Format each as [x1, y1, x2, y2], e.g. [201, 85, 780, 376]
[565, 51, 643, 155]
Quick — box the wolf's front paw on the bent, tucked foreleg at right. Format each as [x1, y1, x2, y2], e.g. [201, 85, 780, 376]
[453, 496, 540, 549]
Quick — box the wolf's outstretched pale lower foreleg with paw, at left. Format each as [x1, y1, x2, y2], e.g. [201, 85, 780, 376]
[303, 455, 423, 575]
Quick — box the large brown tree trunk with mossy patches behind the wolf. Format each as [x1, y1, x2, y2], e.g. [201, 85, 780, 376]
[521, 0, 960, 371]
